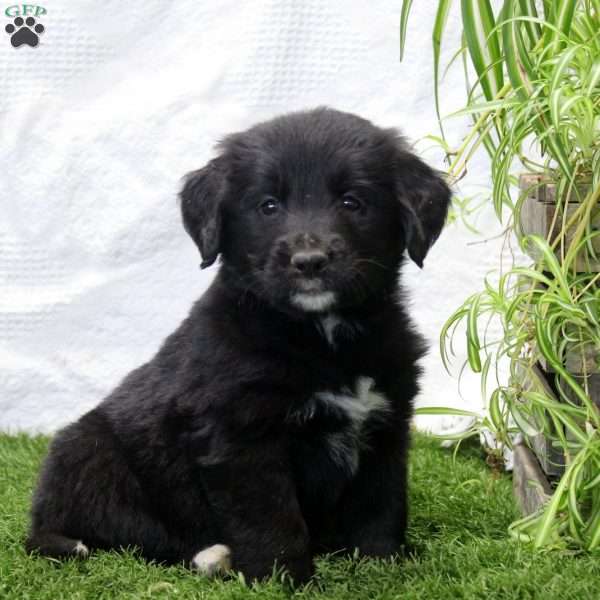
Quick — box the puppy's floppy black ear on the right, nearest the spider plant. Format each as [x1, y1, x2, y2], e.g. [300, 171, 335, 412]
[396, 147, 451, 268]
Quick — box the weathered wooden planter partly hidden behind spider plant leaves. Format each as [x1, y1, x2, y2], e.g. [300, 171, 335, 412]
[513, 175, 600, 514]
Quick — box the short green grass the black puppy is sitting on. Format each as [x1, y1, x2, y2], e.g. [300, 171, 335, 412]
[0, 435, 600, 600]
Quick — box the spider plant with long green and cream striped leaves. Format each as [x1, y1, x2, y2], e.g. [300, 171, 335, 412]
[400, 0, 600, 550]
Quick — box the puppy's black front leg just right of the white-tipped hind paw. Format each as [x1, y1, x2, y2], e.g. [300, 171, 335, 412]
[202, 442, 313, 584]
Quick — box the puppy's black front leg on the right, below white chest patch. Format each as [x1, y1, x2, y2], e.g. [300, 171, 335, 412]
[337, 427, 408, 558]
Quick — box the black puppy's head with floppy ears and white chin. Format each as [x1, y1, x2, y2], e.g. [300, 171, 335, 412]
[181, 108, 450, 312]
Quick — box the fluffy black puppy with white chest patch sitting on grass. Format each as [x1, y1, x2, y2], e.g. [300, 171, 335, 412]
[27, 108, 450, 582]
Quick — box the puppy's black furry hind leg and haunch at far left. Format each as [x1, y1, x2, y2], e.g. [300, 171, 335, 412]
[25, 415, 192, 562]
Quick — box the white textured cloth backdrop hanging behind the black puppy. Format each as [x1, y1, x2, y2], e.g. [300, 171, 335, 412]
[0, 0, 508, 431]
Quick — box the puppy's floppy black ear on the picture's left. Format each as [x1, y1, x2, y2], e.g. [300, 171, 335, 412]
[179, 156, 226, 269]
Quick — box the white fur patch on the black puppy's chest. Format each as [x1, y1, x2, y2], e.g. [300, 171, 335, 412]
[313, 376, 391, 475]
